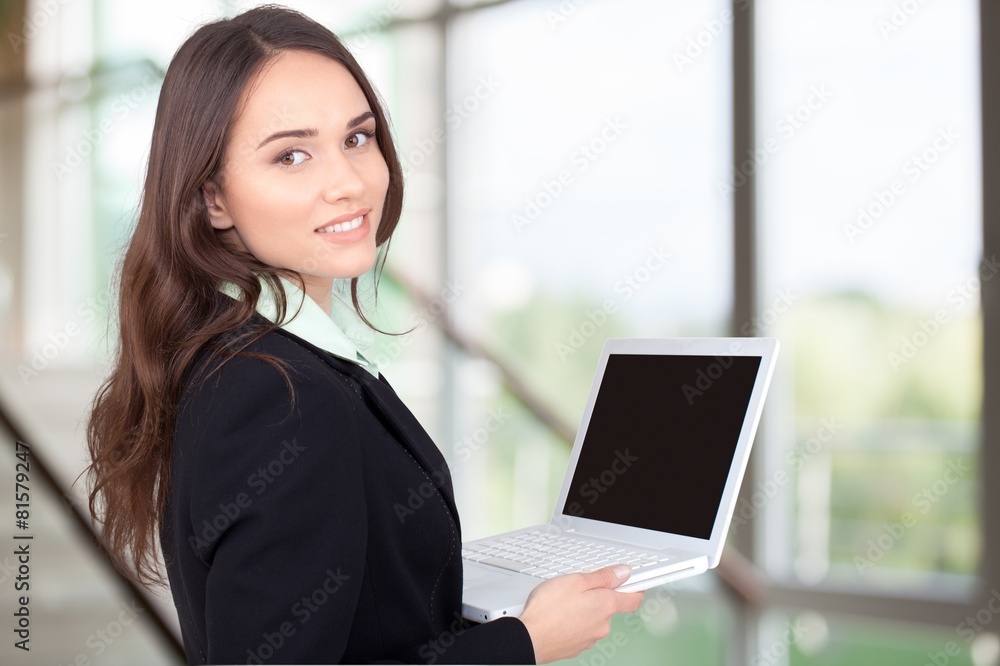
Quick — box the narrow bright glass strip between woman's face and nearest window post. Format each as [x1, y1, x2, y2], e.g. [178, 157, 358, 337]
[355, 23, 451, 436]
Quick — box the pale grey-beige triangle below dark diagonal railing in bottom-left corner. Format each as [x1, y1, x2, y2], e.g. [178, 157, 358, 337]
[0, 429, 176, 666]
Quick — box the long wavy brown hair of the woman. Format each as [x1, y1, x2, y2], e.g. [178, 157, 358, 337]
[87, 5, 403, 586]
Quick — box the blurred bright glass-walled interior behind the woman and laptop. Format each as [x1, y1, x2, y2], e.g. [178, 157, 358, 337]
[0, 0, 1000, 666]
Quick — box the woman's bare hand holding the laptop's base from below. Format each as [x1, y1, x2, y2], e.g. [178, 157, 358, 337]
[520, 564, 644, 664]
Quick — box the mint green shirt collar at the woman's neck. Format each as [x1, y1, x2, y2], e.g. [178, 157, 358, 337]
[219, 277, 378, 378]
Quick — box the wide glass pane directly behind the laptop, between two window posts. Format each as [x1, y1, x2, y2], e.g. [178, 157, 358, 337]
[446, 0, 732, 529]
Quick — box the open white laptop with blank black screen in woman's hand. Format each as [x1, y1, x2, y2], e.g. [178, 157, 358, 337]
[462, 338, 778, 622]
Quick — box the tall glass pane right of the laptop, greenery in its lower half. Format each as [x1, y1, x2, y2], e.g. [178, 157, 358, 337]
[756, 0, 976, 593]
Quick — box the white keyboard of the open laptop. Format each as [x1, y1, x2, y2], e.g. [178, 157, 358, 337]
[462, 530, 671, 579]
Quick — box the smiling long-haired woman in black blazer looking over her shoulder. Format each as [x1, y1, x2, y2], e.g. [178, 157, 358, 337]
[88, 7, 642, 664]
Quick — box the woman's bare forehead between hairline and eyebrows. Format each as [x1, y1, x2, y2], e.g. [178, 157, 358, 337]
[233, 51, 370, 140]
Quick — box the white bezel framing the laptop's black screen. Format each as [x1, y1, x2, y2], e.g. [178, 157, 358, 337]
[550, 337, 780, 568]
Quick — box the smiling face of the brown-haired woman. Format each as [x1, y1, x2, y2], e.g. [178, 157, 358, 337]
[205, 51, 389, 308]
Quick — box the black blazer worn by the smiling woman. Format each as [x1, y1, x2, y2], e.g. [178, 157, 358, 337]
[161, 319, 535, 664]
